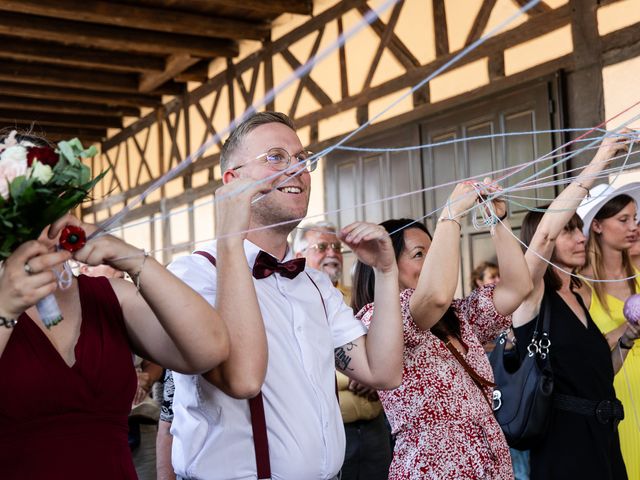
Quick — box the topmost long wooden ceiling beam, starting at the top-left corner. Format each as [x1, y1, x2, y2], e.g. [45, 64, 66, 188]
[0, 0, 270, 40]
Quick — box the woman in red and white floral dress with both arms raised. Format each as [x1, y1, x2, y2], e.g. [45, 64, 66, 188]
[352, 184, 531, 480]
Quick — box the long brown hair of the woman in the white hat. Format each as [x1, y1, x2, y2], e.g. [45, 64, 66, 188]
[587, 194, 637, 312]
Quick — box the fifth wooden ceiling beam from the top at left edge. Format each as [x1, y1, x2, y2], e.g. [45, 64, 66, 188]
[0, 82, 162, 108]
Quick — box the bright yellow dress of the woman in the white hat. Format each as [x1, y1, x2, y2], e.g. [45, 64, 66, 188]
[589, 280, 640, 479]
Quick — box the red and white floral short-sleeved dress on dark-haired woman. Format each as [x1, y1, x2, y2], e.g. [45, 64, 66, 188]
[358, 285, 513, 480]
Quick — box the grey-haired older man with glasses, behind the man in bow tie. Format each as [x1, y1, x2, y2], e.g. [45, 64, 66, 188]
[293, 222, 391, 480]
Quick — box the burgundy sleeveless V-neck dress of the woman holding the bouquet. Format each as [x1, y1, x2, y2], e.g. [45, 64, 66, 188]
[0, 276, 137, 480]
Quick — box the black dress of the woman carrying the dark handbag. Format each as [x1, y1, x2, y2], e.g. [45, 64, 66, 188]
[514, 289, 627, 480]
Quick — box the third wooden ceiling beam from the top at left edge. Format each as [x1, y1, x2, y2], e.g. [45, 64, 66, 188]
[0, 36, 165, 73]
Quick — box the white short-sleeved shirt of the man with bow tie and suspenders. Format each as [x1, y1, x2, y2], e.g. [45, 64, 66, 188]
[169, 240, 366, 480]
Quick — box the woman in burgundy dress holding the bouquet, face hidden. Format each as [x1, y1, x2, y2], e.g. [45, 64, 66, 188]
[0, 217, 228, 480]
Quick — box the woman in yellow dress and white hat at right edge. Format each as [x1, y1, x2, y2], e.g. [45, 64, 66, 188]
[578, 183, 640, 479]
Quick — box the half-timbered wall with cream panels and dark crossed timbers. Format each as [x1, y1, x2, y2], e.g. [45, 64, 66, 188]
[82, 0, 640, 270]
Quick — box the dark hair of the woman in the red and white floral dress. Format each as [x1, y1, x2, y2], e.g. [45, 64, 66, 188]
[351, 218, 460, 338]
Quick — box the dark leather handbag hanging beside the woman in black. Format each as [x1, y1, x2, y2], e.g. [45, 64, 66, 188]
[489, 291, 553, 450]
